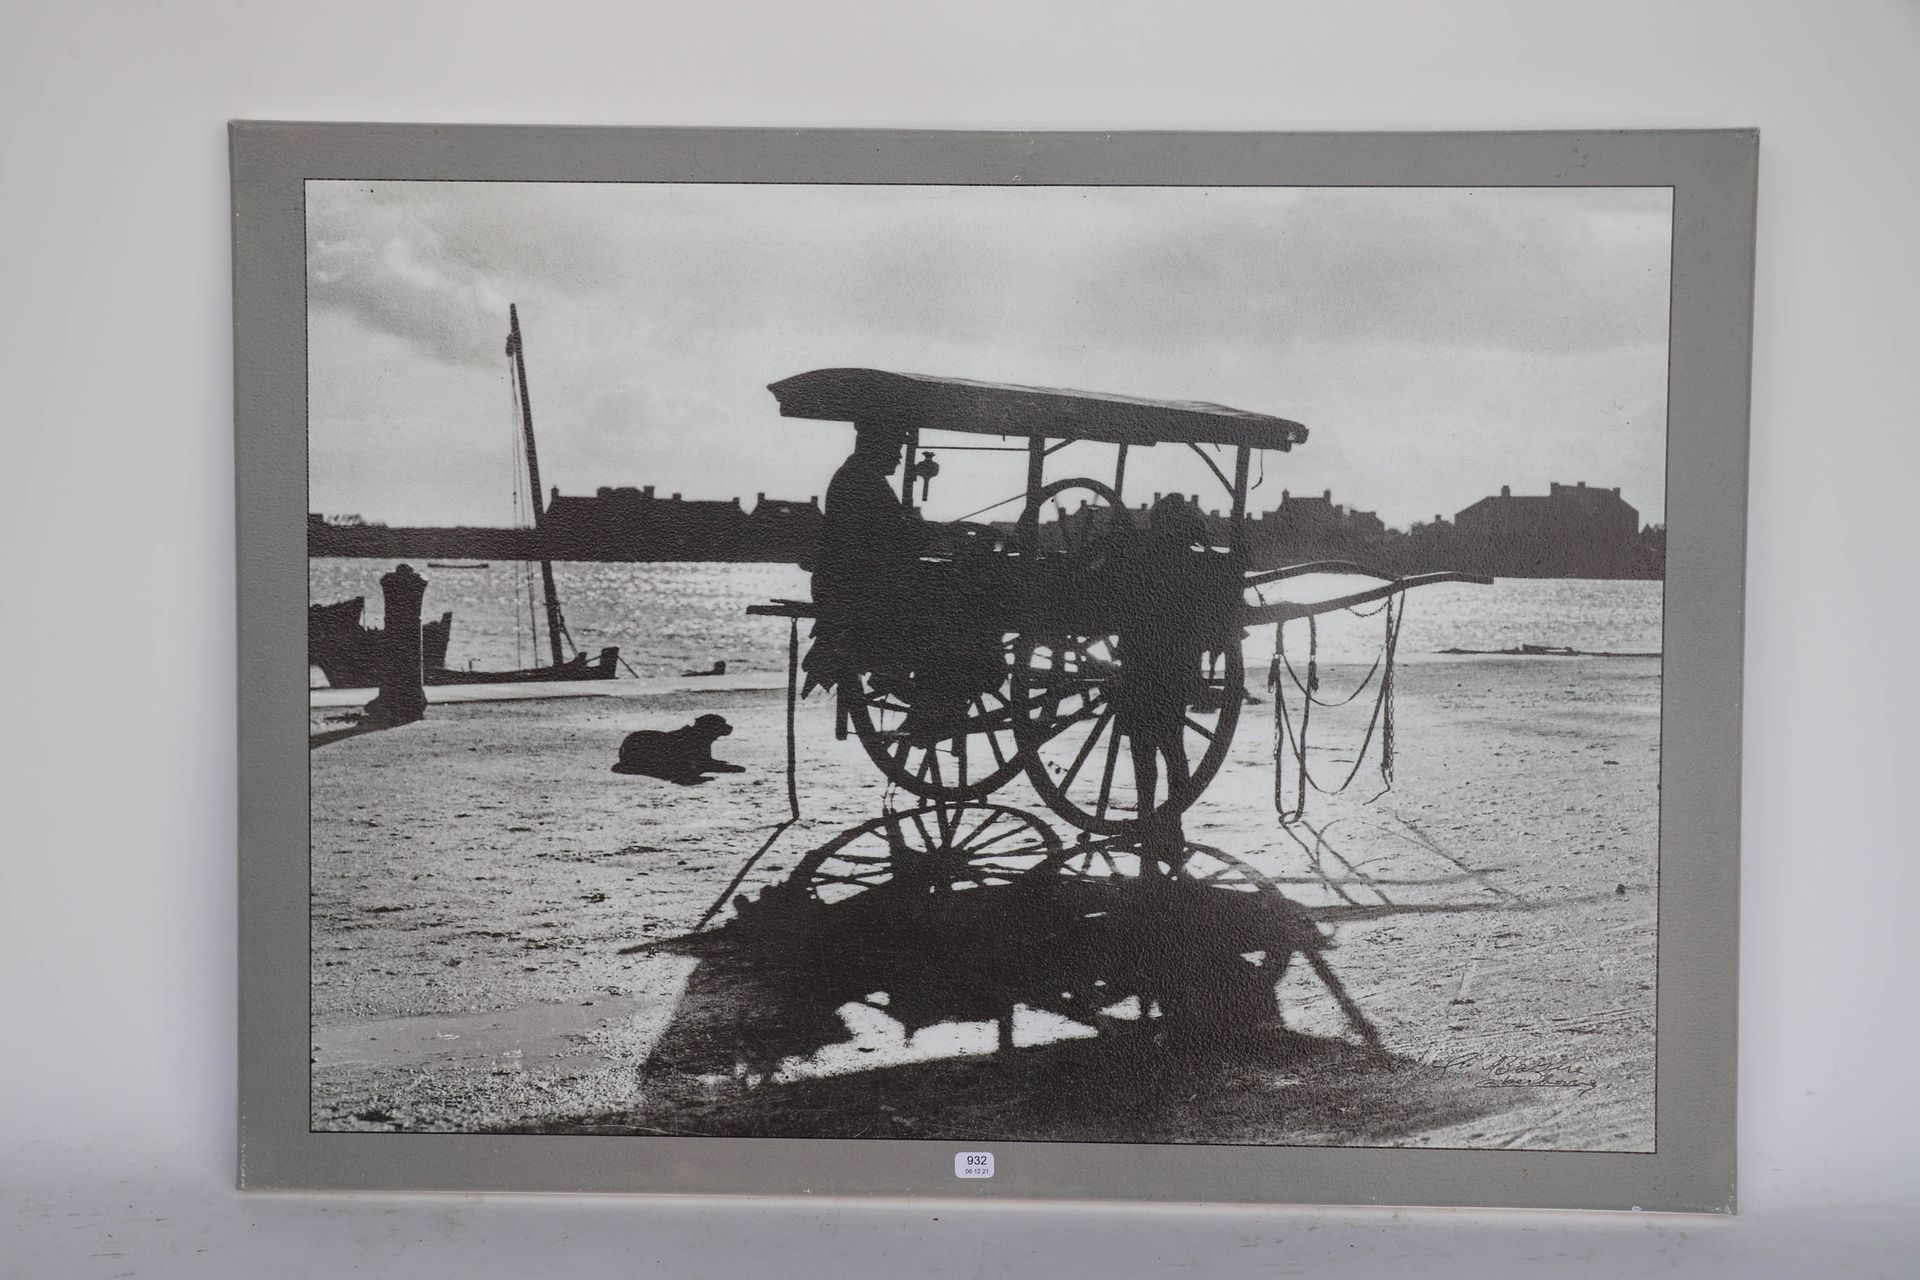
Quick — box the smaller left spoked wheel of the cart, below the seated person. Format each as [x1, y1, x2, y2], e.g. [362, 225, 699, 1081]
[835, 643, 1020, 804]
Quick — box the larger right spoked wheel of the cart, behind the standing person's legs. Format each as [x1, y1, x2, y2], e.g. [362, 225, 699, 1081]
[1014, 635, 1246, 835]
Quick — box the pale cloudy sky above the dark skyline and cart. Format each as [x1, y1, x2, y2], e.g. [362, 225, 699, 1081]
[307, 182, 1670, 526]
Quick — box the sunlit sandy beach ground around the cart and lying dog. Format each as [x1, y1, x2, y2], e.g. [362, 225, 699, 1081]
[311, 656, 1659, 1151]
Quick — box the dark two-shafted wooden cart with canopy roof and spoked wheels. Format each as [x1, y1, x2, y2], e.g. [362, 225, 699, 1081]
[749, 368, 1486, 842]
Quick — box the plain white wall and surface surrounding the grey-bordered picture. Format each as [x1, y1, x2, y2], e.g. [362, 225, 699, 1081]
[0, 0, 1920, 1278]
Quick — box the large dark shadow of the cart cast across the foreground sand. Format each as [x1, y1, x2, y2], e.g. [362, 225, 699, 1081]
[514, 804, 1513, 1144]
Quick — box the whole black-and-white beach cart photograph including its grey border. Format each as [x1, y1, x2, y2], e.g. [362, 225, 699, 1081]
[232, 123, 1757, 1213]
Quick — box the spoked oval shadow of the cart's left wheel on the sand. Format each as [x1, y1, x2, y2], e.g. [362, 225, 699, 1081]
[787, 804, 1062, 906]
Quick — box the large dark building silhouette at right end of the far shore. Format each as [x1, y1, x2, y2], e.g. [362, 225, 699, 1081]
[1453, 480, 1644, 578]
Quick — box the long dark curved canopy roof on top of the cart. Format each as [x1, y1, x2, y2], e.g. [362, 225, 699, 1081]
[768, 368, 1308, 451]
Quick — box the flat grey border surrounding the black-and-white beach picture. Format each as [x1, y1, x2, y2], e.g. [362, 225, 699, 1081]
[230, 121, 1759, 1213]
